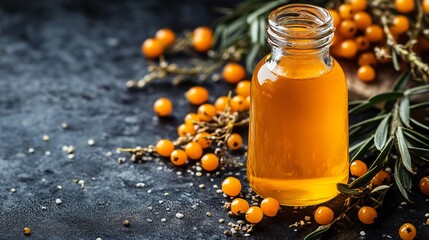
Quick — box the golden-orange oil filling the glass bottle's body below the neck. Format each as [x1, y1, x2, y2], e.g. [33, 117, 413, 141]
[247, 56, 348, 206]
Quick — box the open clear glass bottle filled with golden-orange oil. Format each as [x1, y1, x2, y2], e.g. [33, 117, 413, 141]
[247, 4, 349, 206]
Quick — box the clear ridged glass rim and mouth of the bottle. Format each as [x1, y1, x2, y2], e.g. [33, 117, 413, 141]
[267, 4, 335, 49]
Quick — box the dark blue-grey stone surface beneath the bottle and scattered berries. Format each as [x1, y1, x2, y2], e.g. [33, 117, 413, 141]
[0, 0, 429, 239]
